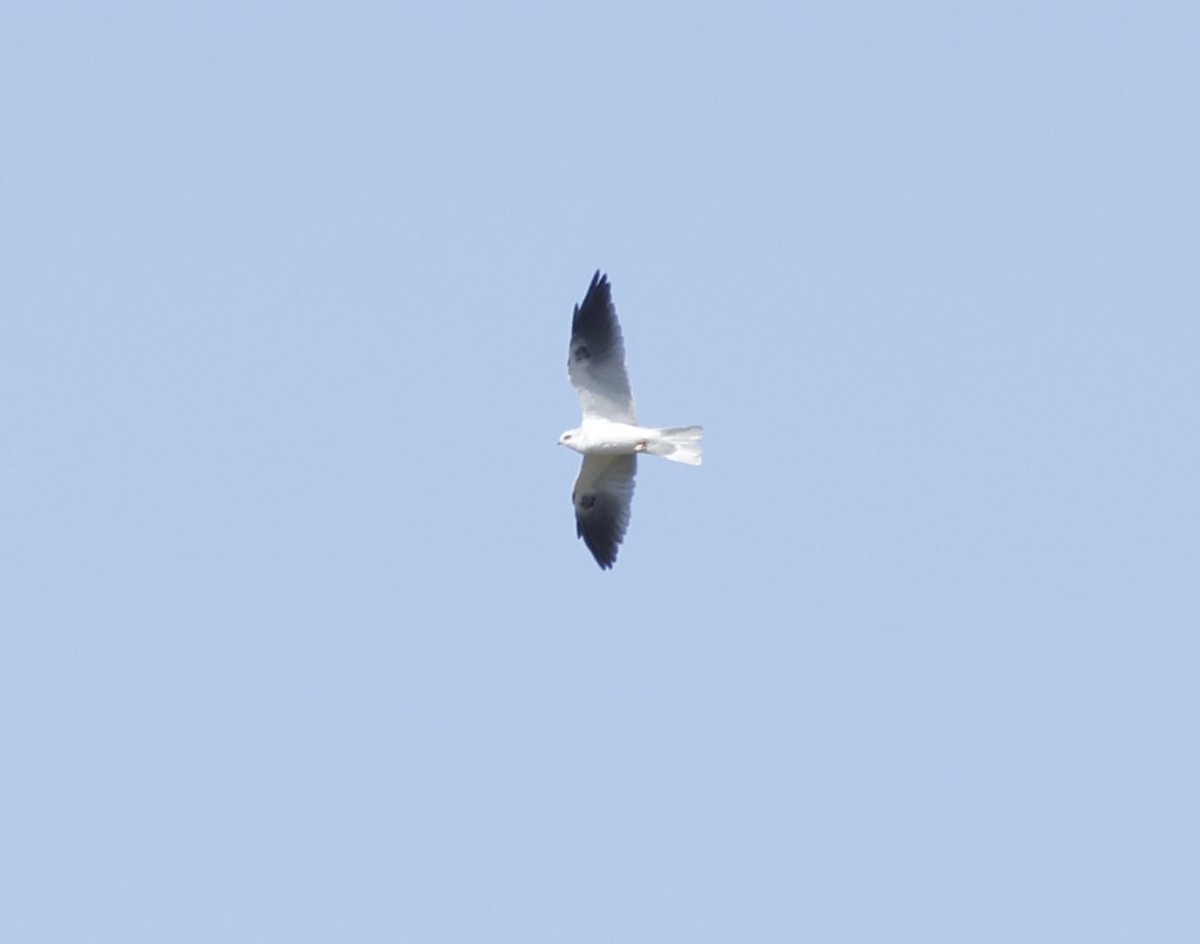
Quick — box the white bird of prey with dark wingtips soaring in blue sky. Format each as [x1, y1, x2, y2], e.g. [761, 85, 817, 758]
[558, 271, 704, 570]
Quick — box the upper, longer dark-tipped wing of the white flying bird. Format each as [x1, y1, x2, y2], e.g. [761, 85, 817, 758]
[566, 271, 637, 423]
